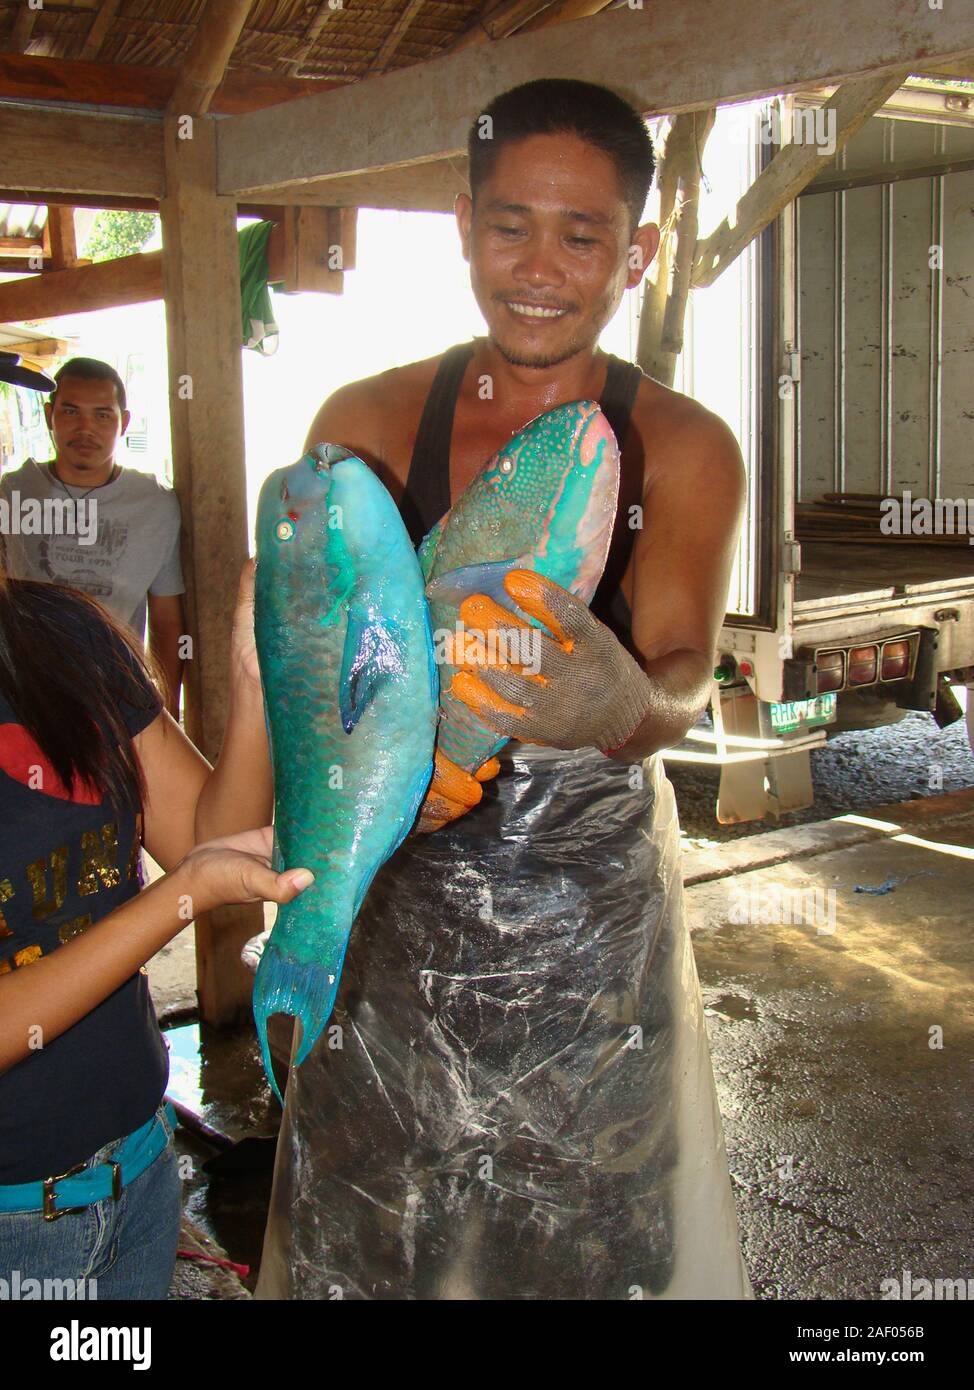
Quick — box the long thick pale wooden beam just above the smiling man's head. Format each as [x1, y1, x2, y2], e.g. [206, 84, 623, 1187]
[217, 0, 974, 196]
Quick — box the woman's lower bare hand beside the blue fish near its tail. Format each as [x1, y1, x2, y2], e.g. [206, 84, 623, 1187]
[172, 826, 314, 916]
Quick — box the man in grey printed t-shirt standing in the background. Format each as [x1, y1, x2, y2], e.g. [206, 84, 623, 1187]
[0, 357, 186, 713]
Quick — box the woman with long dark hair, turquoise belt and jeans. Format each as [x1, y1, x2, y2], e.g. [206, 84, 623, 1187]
[0, 564, 311, 1298]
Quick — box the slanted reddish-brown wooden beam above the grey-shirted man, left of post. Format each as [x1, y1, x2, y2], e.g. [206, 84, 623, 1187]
[0, 252, 163, 324]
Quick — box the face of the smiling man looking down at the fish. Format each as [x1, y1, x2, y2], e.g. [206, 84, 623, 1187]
[456, 133, 659, 367]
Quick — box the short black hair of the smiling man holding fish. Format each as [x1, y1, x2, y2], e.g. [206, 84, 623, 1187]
[467, 78, 656, 232]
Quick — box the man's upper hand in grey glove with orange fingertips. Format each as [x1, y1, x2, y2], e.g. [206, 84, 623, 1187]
[450, 570, 656, 753]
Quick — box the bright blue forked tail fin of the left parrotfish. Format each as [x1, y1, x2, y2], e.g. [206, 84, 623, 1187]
[253, 933, 349, 1104]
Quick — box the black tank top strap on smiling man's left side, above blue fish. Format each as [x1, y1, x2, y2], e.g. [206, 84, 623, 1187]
[400, 342, 474, 545]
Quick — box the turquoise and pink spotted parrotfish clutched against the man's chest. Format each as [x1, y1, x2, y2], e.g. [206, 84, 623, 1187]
[420, 400, 620, 771]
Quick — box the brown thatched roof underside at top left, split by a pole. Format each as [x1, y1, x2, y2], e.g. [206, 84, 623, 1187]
[0, 0, 486, 79]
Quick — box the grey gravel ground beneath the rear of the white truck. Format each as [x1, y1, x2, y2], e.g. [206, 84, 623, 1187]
[667, 712, 974, 842]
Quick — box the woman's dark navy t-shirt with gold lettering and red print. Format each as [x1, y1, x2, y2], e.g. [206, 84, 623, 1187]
[0, 595, 168, 1183]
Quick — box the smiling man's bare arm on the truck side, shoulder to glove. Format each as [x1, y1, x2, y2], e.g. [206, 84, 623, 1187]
[611, 414, 746, 762]
